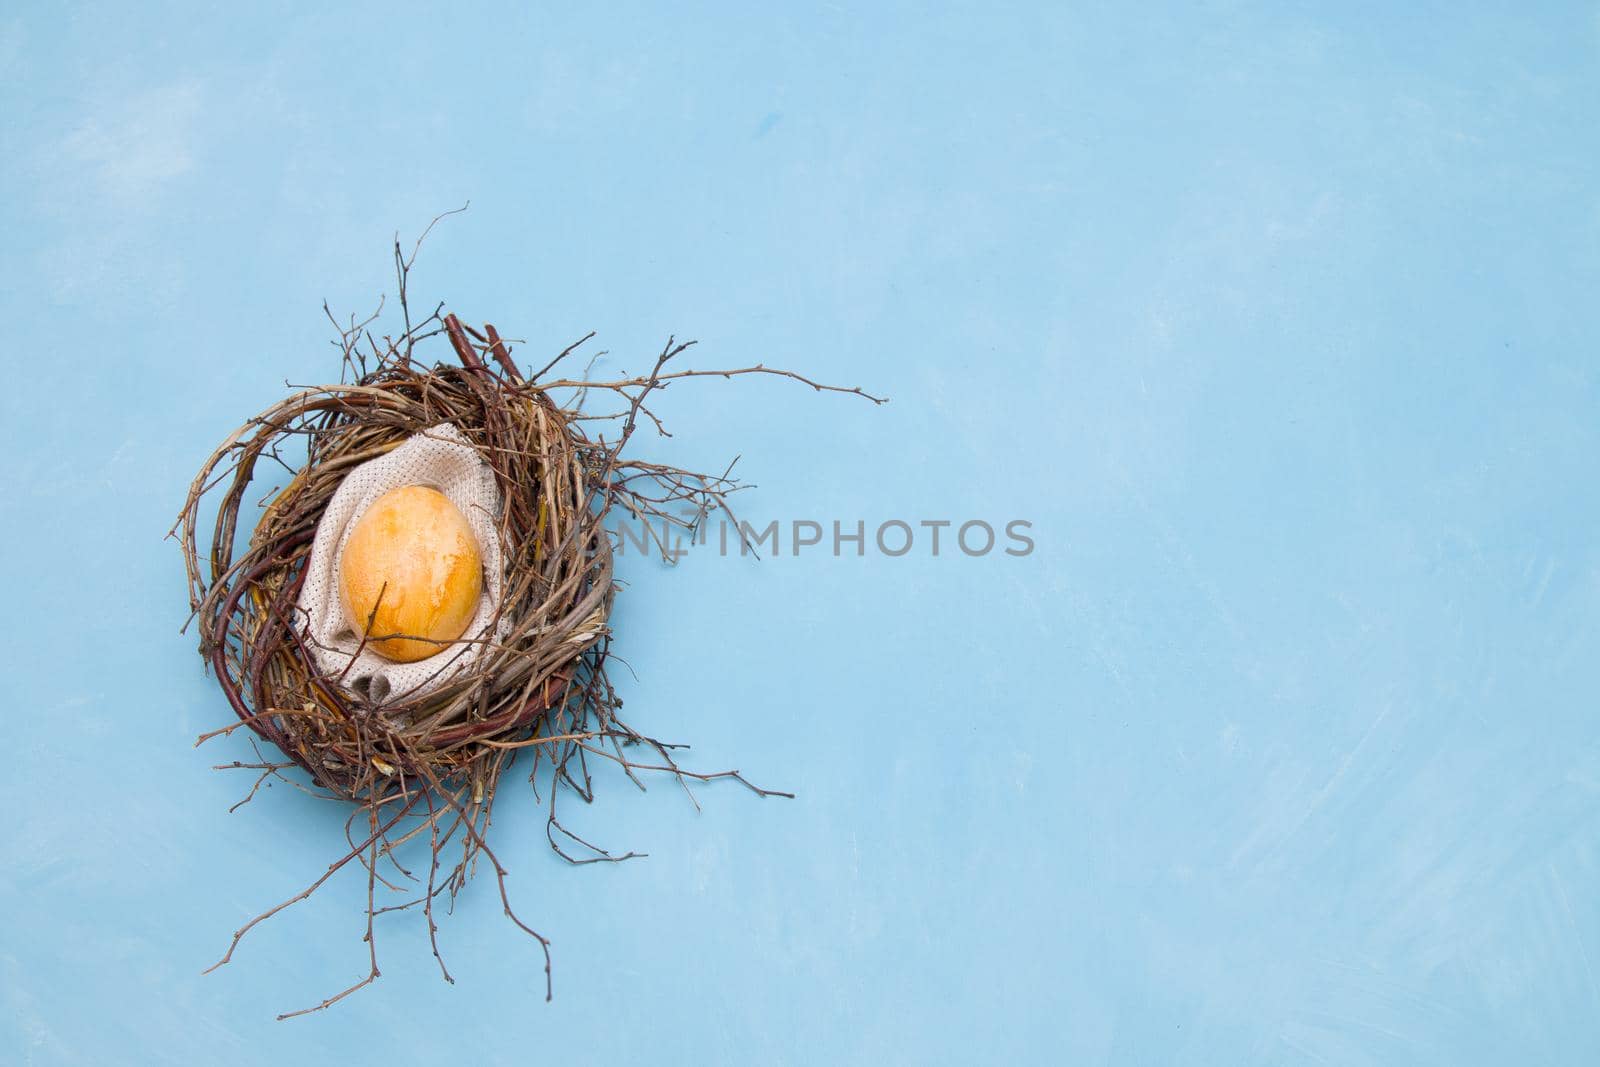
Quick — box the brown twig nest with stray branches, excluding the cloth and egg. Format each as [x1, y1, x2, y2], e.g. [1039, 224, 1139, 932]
[173, 234, 882, 1017]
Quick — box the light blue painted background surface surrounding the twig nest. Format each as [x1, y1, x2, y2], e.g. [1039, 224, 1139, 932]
[0, 3, 1600, 1065]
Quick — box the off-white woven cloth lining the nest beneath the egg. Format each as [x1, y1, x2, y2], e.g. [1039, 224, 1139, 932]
[298, 422, 504, 704]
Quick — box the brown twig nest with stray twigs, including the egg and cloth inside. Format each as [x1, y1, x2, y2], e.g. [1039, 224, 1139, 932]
[173, 267, 882, 1017]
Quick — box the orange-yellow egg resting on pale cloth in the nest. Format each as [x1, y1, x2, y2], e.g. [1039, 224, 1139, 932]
[339, 485, 483, 662]
